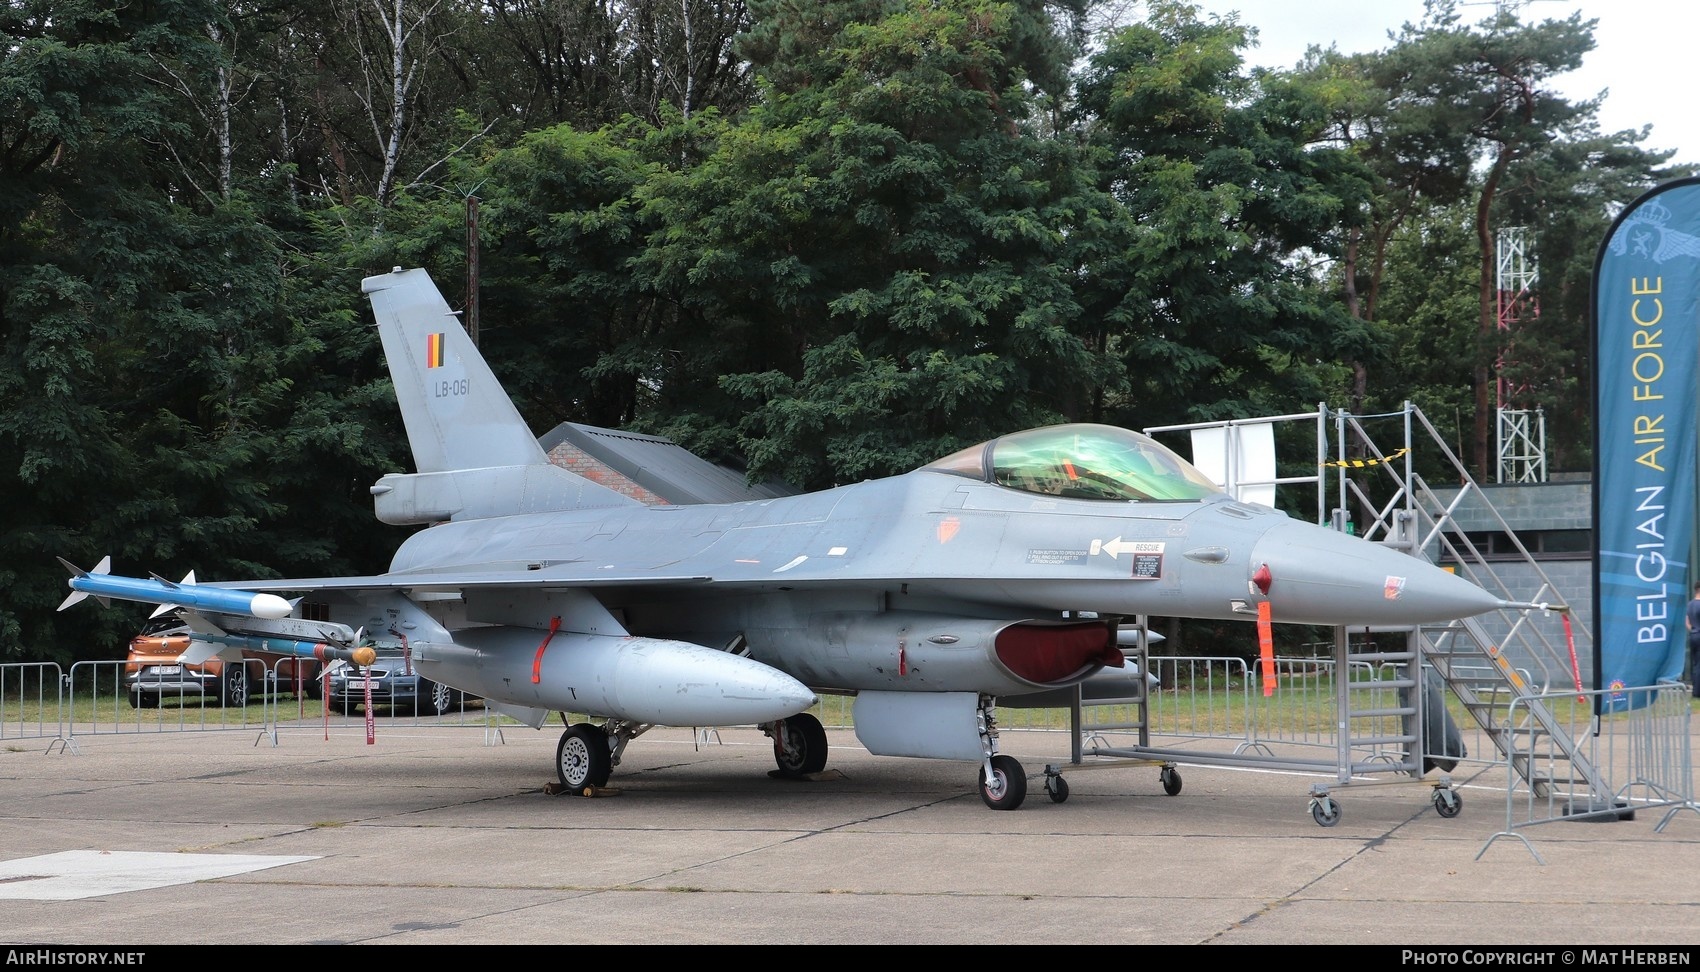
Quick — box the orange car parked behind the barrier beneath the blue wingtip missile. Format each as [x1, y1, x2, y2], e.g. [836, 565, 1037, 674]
[124, 619, 323, 709]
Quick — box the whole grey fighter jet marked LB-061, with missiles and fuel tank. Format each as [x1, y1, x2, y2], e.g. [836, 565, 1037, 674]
[68, 268, 1506, 811]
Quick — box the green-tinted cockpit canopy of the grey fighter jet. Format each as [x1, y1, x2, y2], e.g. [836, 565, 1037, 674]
[921, 425, 1222, 501]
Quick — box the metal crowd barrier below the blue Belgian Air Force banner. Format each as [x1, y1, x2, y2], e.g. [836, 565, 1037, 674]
[1476, 683, 1700, 863]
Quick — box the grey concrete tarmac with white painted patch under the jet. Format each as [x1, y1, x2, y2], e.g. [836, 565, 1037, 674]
[0, 717, 1700, 953]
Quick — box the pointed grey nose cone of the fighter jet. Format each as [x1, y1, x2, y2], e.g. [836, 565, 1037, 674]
[1251, 520, 1499, 625]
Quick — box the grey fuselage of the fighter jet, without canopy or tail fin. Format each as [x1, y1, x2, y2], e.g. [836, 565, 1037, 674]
[391, 471, 1484, 690]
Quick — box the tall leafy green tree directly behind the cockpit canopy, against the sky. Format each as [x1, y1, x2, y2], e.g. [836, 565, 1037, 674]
[1080, 3, 1374, 427]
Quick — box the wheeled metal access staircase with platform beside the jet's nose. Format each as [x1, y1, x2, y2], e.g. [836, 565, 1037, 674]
[1046, 403, 1617, 815]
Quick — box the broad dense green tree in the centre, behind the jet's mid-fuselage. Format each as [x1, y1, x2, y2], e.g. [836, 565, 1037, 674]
[636, 3, 1115, 486]
